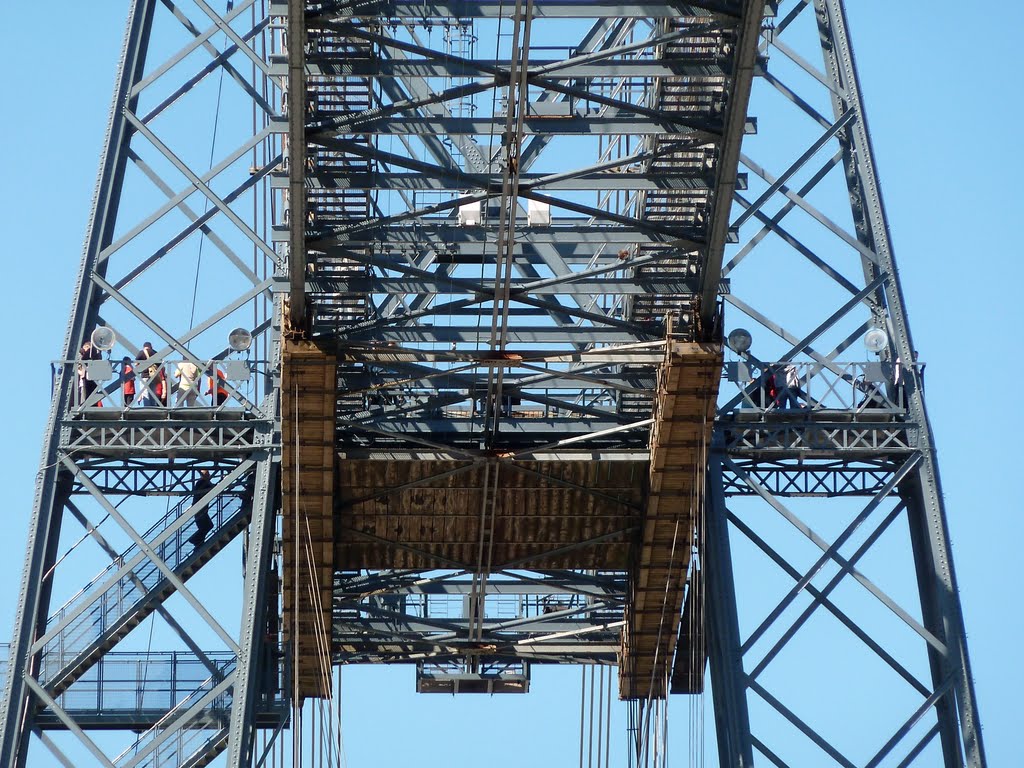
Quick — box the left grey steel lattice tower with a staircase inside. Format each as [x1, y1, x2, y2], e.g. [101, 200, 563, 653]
[0, 0, 284, 767]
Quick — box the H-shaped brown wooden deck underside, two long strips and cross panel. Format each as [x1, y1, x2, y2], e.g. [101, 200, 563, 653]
[282, 341, 722, 698]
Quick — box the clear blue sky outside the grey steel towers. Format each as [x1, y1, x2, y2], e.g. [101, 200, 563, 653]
[0, 0, 1024, 766]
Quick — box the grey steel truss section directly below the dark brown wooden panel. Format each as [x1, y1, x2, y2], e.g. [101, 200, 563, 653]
[334, 570, 626, 666]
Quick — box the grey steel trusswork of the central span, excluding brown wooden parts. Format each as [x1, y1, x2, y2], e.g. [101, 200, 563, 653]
[284, 1, 761, 708]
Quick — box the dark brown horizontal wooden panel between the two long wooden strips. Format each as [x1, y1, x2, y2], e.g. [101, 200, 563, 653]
[335, 460, 646, 570]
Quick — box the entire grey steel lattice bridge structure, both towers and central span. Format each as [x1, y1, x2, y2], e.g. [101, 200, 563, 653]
[0, 0, 985, 768]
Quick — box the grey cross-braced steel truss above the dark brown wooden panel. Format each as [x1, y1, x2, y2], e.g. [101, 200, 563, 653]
[279, 3, 752, 456]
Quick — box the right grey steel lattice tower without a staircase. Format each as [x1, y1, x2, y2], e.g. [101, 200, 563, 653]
[707, 0, 985, 767]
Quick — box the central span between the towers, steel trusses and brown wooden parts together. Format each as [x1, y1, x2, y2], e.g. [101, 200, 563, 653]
[276, 2, 763, 699]
